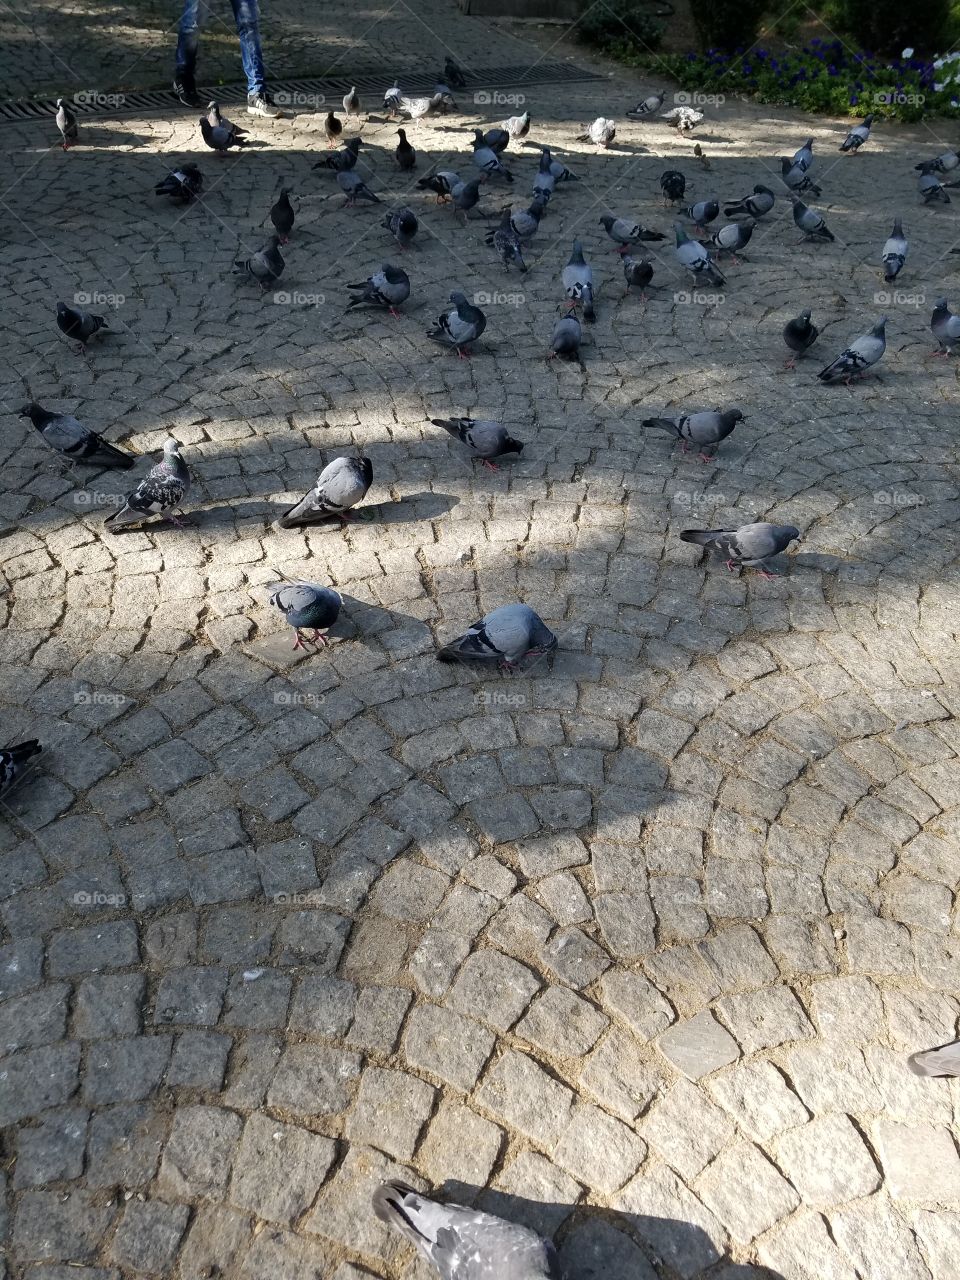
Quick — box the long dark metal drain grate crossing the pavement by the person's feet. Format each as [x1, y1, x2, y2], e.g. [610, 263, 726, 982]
[0, 63, 603, 124]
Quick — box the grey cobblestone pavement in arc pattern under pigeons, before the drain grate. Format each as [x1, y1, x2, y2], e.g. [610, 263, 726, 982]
[0, 2, 960, 1280]
